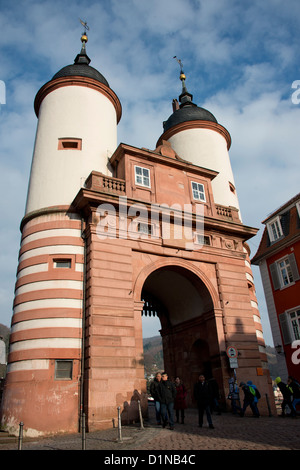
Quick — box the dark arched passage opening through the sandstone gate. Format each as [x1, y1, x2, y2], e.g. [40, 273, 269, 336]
[135, 260, 223, 405]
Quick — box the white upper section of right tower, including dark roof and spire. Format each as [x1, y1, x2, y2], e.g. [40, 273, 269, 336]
[157, 70, 239, 216]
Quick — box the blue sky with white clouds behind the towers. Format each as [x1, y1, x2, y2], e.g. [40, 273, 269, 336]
[0, 0, 300, 344]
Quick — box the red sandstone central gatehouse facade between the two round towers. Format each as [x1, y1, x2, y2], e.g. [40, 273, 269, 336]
[74, 143, 272, 429]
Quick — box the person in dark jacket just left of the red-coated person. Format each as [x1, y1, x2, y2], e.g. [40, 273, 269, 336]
[157, 372, 176, 430]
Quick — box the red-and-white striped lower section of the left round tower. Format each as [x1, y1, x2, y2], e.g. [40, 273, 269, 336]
[2, 210, 84, 436]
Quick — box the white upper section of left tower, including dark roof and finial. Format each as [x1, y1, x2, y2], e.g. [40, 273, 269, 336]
[25, 34, 121, 214]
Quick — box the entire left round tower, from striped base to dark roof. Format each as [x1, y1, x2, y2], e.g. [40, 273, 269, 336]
[2, 34, 121, 436]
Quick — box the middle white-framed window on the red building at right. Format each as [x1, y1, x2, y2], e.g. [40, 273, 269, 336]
[270, 253, 300, 290]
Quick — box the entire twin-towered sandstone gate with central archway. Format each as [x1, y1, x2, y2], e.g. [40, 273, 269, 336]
[1, 34, 273, 436]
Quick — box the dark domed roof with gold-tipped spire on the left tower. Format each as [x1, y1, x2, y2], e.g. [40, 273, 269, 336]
[52, 33, 109, 87]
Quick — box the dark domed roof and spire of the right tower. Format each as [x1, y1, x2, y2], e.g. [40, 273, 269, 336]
[163, 56, 218, 132]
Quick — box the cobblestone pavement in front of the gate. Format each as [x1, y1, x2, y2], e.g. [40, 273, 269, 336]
[0, 407, 300, 452]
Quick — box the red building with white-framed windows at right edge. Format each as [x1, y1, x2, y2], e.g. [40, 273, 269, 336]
[252, 194, 300, 381]
